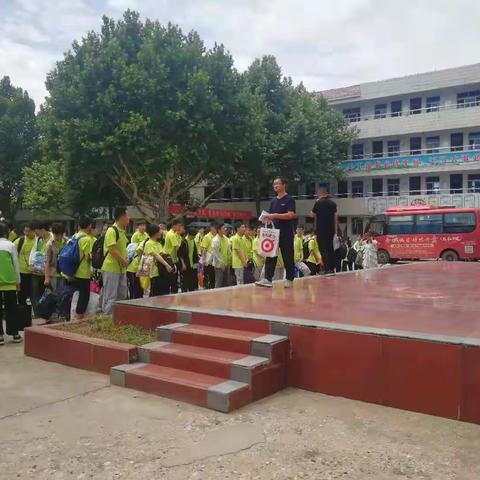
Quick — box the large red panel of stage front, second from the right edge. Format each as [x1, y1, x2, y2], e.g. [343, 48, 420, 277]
[382, 337, 462, 418]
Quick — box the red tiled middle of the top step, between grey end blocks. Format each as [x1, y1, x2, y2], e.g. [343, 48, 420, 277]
[172, 325, 259, 355]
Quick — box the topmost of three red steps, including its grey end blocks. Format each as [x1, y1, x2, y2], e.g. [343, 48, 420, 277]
[157, 323, 289, 363]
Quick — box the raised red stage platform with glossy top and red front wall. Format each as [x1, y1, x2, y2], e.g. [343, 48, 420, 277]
[115, 262, 480, 423]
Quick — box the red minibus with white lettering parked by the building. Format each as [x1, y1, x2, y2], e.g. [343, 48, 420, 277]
[368, 206, 480, 263]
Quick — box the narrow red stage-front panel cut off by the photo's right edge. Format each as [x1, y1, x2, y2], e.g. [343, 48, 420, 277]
[460, 347, 480, 424]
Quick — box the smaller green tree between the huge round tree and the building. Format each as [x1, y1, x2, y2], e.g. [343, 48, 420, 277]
[242, 56, 355, 211]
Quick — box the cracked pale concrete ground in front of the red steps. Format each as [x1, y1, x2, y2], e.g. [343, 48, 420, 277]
[0, 344, 480, 480]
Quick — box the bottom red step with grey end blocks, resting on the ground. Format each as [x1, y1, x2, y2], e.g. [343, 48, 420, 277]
[110, 363, 252, 413]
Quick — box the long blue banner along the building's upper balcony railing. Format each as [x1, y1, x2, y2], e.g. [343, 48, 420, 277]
[340, 150, 480, 172]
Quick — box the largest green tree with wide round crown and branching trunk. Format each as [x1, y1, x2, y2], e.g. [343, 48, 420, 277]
[42, 11, 256, 220]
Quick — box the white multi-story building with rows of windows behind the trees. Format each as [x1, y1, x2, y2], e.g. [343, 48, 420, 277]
[203, 64, 480, 235]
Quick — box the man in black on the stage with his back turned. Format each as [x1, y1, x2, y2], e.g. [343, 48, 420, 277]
[310, 187, 338, 273]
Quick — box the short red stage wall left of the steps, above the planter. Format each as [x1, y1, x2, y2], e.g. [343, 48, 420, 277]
[113, 303, 177, 330]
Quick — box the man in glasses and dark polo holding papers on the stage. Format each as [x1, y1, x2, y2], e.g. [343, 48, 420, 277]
[256, 177, 297, 288]
